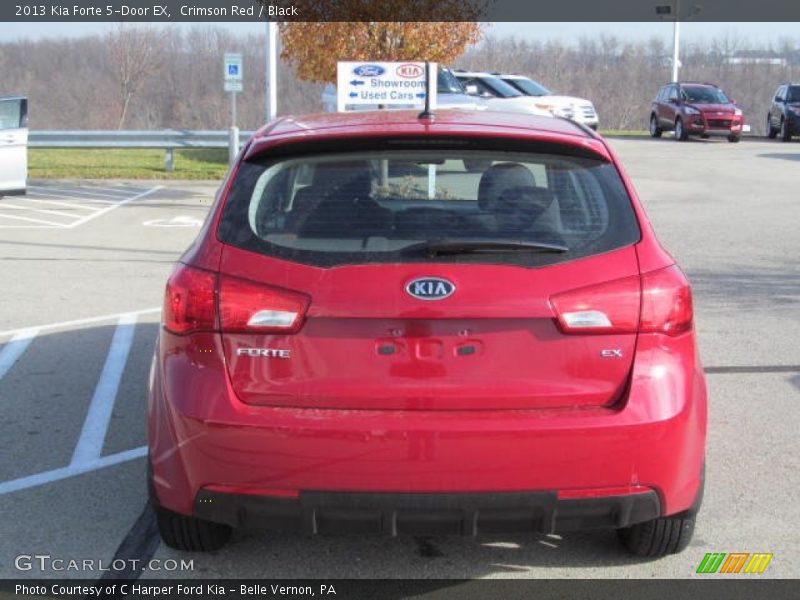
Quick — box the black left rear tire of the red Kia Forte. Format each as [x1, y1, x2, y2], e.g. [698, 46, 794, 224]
[147, 460, 233, 552]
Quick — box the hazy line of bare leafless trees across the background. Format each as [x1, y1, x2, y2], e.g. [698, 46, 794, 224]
[0, 26, 800, 133]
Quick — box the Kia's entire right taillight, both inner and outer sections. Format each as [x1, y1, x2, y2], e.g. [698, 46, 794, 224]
[550, 265, 692, 336]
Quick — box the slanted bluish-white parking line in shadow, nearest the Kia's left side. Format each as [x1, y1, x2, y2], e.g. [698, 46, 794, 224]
[70, 314, 136, 466]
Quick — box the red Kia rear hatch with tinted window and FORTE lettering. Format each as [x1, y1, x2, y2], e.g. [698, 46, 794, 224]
[218, 140, 640, 410]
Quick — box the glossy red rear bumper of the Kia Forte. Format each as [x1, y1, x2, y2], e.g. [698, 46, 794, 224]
[148, 334, 706, 530]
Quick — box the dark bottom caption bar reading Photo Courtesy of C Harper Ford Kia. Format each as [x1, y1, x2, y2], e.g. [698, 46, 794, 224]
[0, 580, 797, 600]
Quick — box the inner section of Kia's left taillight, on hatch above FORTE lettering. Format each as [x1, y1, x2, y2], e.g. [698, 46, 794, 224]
[219, 276, 309, 333]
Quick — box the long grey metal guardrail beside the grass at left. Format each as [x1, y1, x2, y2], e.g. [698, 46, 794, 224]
[28, 129, 253, 172]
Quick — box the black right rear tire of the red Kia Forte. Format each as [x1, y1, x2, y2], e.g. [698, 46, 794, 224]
[617, 511, 695, 558]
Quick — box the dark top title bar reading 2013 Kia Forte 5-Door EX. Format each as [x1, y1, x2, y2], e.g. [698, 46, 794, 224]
[0, 0, 800, 23]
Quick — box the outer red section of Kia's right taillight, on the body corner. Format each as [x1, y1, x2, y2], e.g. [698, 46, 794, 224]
[639, 265, 694, 335]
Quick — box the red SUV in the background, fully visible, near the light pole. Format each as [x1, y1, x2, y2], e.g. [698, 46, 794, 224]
[650, 82, 744, 142]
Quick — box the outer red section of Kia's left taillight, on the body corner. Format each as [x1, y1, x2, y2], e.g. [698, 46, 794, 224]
[161, 264, 217, 334]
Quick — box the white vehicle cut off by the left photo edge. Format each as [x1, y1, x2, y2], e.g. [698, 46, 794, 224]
[0, 96, 28, 196]
